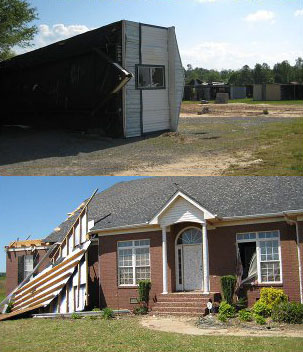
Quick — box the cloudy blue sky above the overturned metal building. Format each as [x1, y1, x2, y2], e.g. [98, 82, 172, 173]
[18, 0, 303, 69]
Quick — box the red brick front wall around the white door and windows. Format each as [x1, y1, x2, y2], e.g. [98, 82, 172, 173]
[99, 222, 303, 309]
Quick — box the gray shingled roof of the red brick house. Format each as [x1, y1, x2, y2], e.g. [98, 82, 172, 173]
[45, 176, 303, 241]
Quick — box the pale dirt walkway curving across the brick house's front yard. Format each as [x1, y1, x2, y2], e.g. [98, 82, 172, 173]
[141, 316, 303, 338]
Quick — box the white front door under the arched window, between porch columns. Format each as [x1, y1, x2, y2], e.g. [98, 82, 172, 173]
[183, 244, 203, 291]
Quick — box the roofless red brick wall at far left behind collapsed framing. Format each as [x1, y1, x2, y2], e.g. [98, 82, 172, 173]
[6, 249, 48, 295]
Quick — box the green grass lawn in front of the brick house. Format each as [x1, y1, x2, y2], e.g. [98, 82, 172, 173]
[0, 318, 303, 352]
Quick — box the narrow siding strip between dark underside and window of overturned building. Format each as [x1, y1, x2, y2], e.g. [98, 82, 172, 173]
[125, 21, 141, 137]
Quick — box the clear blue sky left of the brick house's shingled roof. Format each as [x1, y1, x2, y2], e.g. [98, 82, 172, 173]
[0, 176, 147, 272]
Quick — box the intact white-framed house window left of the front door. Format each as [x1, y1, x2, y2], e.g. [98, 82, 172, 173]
[118, 240, 150, 286]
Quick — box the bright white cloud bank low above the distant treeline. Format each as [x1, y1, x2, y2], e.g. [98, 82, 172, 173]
[180, 41, 303, 70]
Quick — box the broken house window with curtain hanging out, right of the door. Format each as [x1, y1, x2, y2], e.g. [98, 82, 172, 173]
[237, 231, 282, 283]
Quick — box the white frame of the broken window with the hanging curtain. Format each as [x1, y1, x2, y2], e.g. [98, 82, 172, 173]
[236, 230, 283, 285]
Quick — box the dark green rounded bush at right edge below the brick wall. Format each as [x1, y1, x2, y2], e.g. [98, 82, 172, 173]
[272, 302, 303, 324]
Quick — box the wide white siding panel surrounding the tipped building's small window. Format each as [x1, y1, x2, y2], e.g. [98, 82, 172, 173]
[141, 25, 170, 133]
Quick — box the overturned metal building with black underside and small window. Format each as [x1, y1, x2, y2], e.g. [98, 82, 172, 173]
[0, 20, 184, 137]
